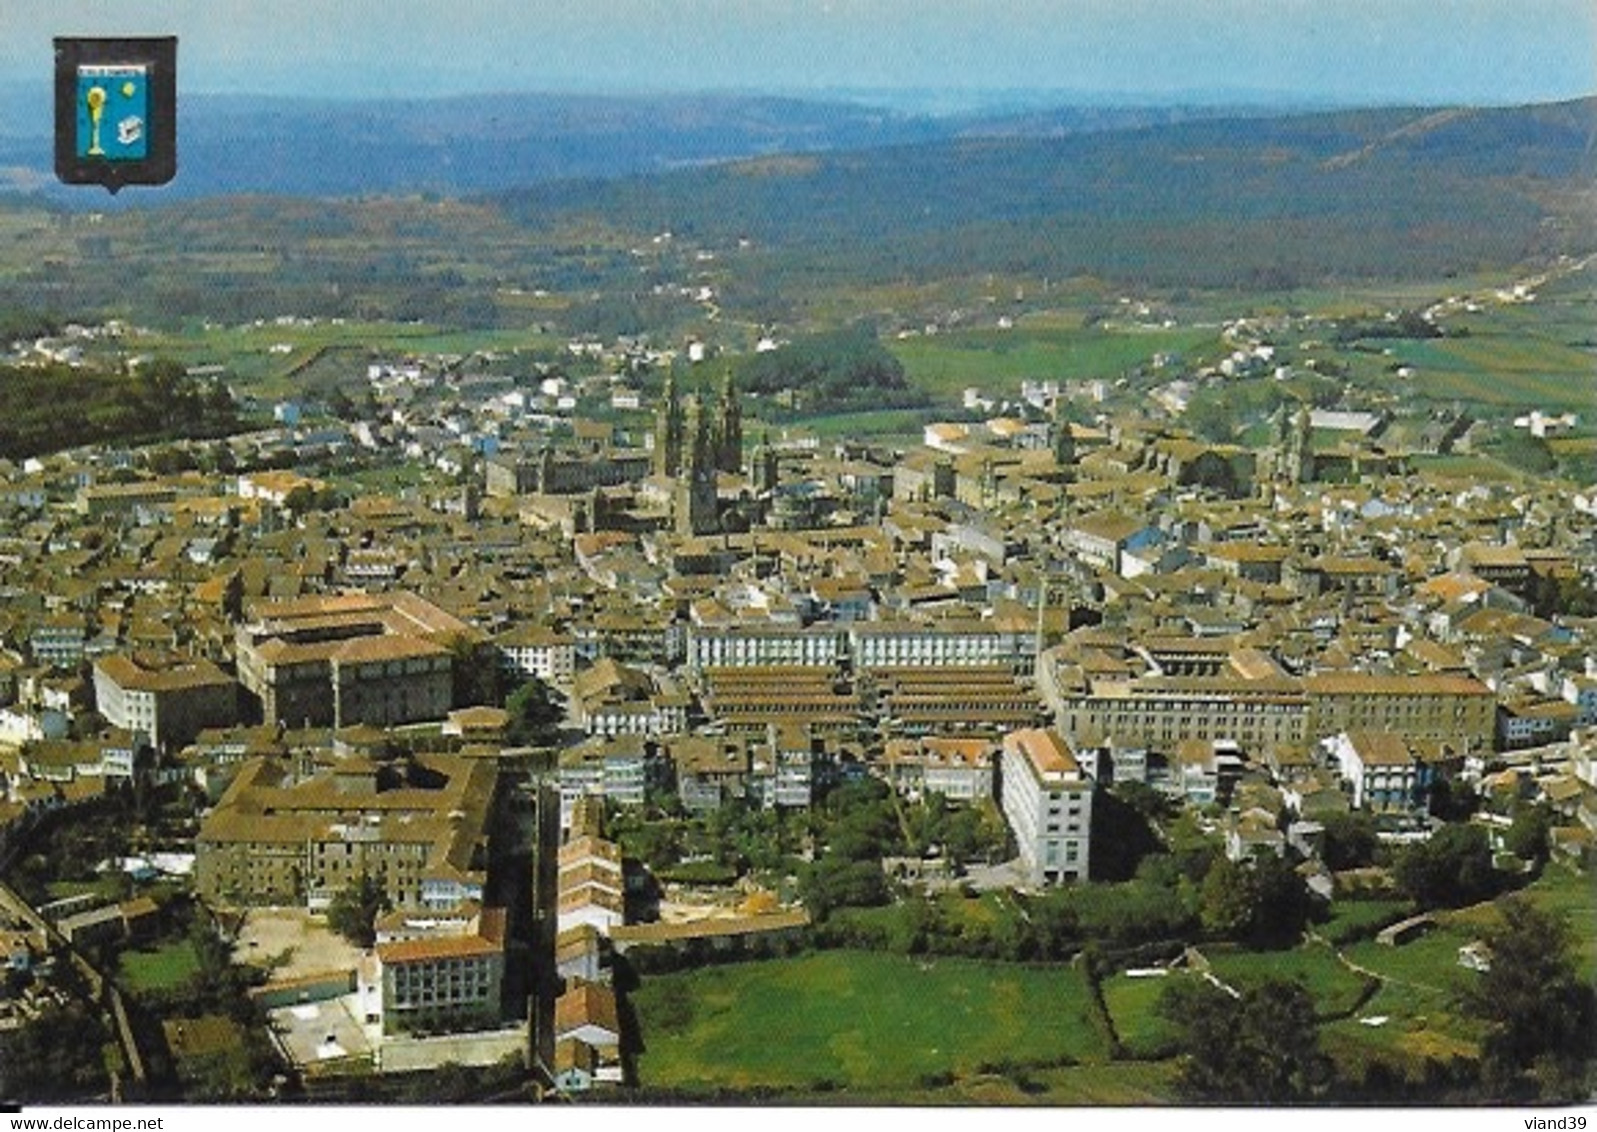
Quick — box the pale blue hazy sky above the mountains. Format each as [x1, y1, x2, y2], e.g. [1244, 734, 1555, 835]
[12, 0, 1597, 102]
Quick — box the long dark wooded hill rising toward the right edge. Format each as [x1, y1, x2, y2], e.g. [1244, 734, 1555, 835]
[495, 99, 1597, 287]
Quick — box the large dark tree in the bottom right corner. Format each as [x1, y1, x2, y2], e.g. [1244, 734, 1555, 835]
[1460, 894, 1597, 1102]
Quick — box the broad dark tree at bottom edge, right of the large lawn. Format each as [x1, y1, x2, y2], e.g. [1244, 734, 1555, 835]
[1158, 979, 1332, 1105]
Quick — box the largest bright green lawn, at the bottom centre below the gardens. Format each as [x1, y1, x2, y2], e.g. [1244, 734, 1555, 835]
[632, 952, 1107, 1090]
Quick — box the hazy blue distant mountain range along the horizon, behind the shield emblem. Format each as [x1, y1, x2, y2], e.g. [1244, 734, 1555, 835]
[0, 86, 1347, 204]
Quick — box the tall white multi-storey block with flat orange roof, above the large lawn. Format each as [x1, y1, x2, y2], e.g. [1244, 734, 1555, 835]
[1000, 728, 1092, 886]
